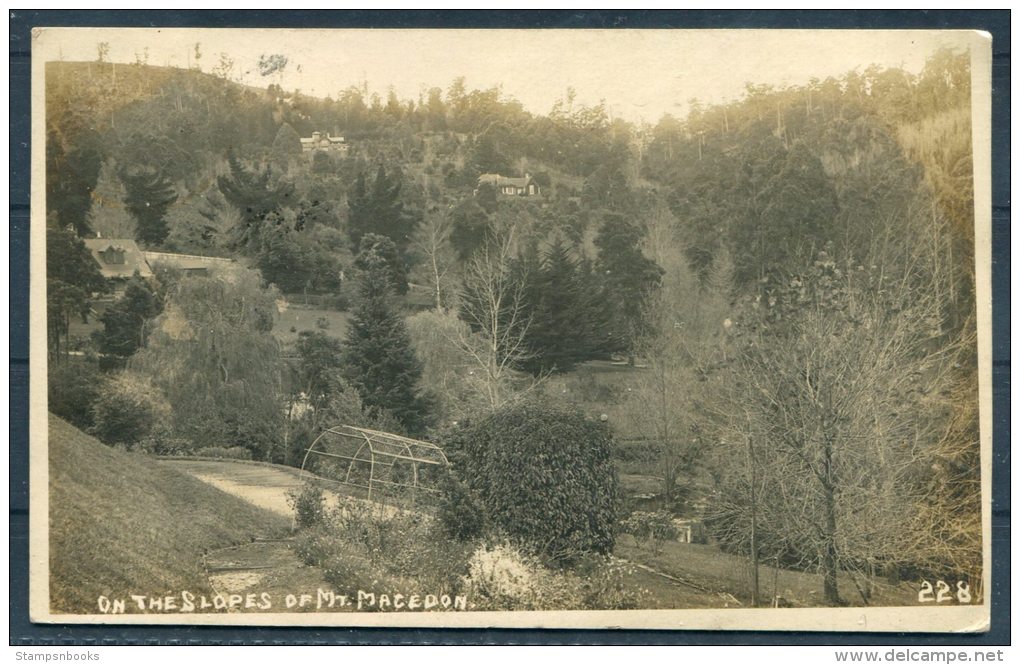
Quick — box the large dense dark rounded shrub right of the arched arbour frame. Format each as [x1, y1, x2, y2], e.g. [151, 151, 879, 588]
[447, 403, 618, 563]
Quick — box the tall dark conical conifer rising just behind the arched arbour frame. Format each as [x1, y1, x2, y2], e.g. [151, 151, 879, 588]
[344, 252, 429, 436]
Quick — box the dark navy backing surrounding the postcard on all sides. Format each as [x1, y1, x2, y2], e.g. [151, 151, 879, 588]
[9, 9, 1011, 647]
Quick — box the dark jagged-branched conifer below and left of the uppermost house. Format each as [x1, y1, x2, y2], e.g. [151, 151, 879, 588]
[216, 152, 294, 250]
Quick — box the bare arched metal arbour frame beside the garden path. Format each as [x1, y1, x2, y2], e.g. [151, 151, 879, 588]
[301, 425, 450, 499]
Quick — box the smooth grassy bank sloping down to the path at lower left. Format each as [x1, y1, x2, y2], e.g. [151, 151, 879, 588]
[49, 415, 290, 613]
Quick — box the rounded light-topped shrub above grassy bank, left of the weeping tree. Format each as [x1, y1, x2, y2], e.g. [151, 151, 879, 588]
[93, 372, 170, 446]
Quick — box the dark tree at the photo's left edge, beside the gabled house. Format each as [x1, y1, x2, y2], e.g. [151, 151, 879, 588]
[46, 228, 109, 359]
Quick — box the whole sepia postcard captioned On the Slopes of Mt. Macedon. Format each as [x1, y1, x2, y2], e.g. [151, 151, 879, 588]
[30, 28, 991, 632]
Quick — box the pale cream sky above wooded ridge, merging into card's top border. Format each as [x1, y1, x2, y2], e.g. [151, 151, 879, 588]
[33, 29, 973, 123]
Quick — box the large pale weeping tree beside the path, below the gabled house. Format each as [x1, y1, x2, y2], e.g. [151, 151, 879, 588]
[129, 271, 285, 460]
